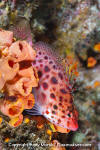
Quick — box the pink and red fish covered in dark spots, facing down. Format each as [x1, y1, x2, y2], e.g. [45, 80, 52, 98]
[27, 42, 78, 131]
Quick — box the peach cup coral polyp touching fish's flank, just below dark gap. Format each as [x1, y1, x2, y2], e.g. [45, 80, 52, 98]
[6, 66, 38, 96]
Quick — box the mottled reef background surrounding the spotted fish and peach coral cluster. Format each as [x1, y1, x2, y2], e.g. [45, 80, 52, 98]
[0, 0, 100, 150]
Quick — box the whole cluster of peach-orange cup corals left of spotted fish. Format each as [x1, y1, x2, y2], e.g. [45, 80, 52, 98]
[0, 29, 38, 127]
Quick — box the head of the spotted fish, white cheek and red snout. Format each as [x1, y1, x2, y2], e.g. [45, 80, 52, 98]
[45, 92, 78, 131]
